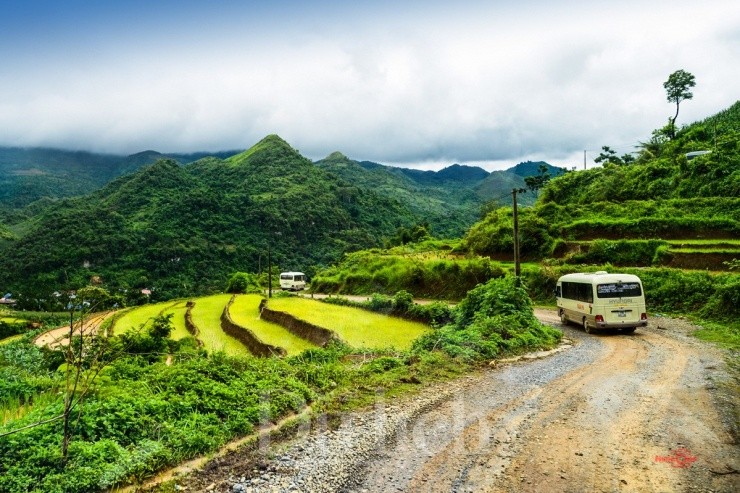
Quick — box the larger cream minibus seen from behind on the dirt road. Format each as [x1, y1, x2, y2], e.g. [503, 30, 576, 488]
[555, 271, 647, 333]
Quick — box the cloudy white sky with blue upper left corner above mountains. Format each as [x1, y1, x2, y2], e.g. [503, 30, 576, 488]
[0, 0, 740, 170]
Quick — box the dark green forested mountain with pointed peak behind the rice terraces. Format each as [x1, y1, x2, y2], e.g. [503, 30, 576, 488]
[0, 136, 415, 299]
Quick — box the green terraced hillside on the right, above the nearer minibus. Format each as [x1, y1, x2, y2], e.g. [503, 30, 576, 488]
[464, 102, 740, 270]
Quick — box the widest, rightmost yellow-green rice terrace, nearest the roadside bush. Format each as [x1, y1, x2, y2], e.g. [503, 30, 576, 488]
[268, 297, 431, 350]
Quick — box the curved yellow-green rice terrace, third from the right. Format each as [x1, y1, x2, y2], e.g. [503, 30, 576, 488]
[191, 294, 251, 356]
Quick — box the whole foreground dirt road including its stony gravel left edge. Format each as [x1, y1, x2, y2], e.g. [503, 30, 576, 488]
[169, 311, 740, 493]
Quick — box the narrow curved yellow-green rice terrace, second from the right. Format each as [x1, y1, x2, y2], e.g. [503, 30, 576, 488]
[229, 294, 316, 356]
